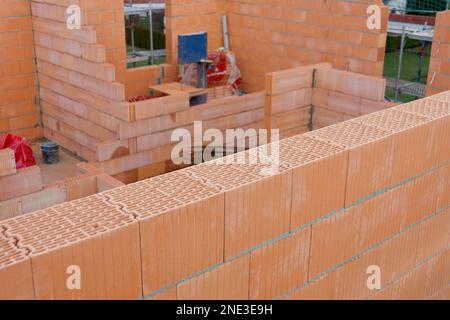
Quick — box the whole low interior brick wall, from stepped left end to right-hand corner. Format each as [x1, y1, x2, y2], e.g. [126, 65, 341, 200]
[95, 63, 386, 182]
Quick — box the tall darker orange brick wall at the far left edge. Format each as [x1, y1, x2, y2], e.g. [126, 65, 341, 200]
[0, 0, 42, 139]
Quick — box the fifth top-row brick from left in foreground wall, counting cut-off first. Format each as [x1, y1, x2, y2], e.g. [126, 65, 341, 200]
[280, 135, 348, 230]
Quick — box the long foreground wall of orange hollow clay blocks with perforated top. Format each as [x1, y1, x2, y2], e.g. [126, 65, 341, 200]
[0, 92, 450, 299]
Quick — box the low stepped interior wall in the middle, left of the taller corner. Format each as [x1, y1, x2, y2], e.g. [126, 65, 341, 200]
[96, 92, 264, 180]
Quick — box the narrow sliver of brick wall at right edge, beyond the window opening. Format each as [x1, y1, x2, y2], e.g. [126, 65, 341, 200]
[427, 10, 450, 95]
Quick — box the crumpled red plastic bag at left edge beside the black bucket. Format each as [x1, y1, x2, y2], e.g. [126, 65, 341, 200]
[0, 133, 36, 169]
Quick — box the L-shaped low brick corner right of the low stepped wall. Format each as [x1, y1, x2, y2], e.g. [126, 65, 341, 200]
[265, 63, 391, 138]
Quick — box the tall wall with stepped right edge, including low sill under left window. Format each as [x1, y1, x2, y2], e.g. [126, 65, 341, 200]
[31, 0, 173, 161]
